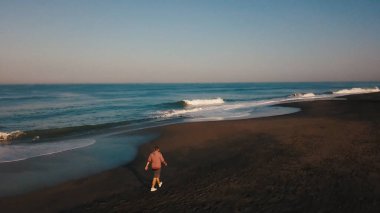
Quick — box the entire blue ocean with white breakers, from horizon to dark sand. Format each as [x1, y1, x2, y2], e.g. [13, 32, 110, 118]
[0, 82, 380, 196]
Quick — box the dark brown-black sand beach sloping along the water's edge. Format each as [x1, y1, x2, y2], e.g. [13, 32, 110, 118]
[0, 93, 380, 212]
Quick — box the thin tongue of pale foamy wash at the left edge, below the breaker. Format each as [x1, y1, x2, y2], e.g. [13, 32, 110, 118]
[0, 139, 96, 163]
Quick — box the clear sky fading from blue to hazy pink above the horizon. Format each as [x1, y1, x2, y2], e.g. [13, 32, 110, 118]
[0, 0, 380, 84]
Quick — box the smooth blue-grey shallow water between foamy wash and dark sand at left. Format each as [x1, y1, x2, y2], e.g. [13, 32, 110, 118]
[0, 133, 156, 196]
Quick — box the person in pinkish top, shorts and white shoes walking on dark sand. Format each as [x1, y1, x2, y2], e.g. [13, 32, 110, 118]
[145, 146, 168, 192]
